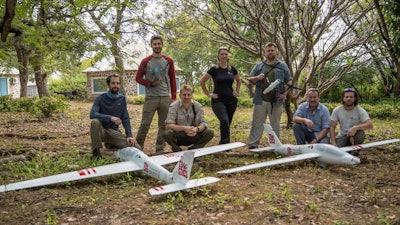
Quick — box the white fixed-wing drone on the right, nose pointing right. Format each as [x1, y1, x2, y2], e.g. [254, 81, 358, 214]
[217, 124, 400, 174]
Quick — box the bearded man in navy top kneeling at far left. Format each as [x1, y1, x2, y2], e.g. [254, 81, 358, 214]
[90, 74, 137, 159]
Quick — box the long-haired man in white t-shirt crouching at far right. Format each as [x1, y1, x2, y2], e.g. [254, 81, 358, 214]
[329, 88, 373, 147]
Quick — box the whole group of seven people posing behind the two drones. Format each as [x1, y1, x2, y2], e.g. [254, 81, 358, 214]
[90, 36, 372, 159]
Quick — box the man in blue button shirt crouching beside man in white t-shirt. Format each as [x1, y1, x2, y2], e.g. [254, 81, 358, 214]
[293, 88, 330, 145]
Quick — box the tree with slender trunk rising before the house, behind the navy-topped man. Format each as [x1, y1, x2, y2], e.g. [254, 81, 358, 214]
[82, 0, 153, 94]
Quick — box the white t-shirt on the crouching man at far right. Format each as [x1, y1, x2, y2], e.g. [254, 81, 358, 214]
[331, 105, 370, 137]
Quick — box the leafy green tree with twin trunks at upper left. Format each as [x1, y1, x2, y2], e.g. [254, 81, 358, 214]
[0, 0, 90, 97]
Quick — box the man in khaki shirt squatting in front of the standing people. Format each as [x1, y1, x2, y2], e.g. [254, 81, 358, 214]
[164, 84, 214, 152]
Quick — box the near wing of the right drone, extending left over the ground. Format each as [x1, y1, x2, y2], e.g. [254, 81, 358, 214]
[217, 153, 320, 174]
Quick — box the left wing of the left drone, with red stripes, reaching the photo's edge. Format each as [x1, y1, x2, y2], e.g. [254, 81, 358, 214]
[0, 161, 141, 192]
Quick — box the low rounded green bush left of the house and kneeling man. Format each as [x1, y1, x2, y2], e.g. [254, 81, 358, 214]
[33, 96, 68, 117]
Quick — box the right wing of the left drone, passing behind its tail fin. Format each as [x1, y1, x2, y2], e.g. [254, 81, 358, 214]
[150, 142, 246, 166]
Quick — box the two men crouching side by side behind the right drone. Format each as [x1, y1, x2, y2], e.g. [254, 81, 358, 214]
[293, 88, 373, 147]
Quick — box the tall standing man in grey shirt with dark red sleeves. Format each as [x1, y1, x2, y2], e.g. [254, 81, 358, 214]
[136, 35, 176, 153]
